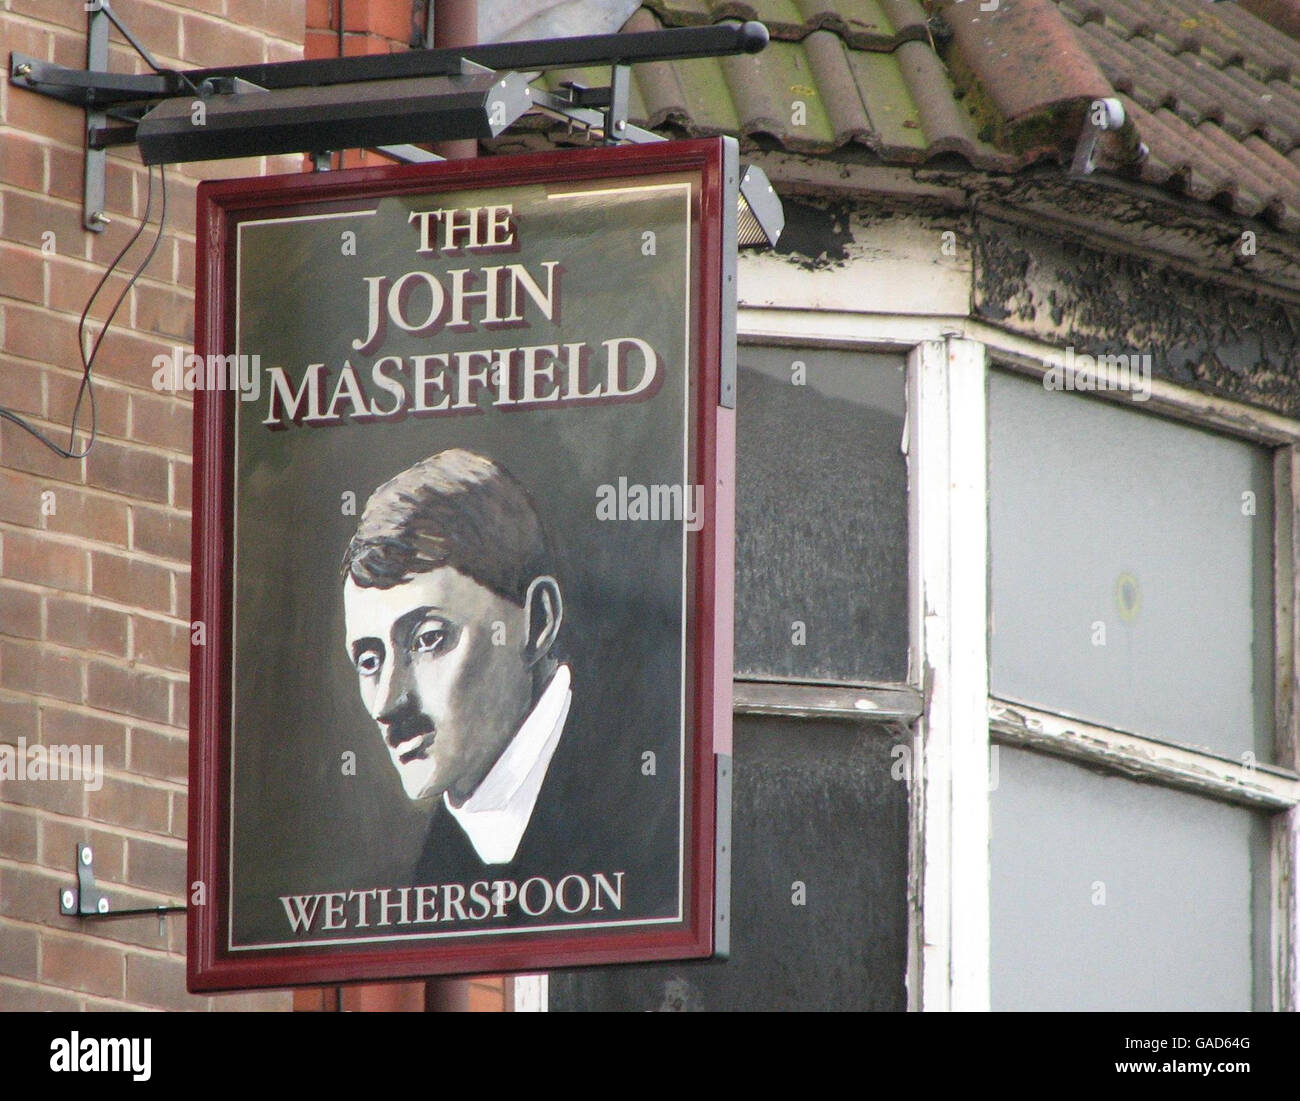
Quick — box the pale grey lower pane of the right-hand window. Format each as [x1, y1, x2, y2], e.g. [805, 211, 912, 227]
[989, 746, 1269, 1010]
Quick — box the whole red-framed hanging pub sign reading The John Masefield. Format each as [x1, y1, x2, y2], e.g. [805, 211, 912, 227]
[189, 139, 736, 991]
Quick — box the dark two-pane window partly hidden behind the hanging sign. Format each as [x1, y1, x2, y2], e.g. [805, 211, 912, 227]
[549, 344, 919, 1010]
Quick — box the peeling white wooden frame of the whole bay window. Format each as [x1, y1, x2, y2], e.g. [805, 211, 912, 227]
[525, 308, 1300, 1011]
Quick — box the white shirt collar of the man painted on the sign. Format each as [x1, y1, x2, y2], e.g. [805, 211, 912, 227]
[442, 666, 573, 864]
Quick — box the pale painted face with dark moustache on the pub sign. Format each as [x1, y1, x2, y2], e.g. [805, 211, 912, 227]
[343, 565, 533, 803]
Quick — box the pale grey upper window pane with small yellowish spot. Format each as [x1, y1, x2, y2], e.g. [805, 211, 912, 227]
[988, 372, 1273, 760]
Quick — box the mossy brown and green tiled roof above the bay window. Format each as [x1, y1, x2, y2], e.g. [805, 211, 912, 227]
[527, 0, 1300, 233]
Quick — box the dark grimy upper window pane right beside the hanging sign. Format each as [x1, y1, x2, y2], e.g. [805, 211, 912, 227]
[736, 347, 907, 681]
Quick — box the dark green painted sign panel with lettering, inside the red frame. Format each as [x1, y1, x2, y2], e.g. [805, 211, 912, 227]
[213, 163, 720, 974]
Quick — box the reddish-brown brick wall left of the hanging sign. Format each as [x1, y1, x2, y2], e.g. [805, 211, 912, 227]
[0, 0, 306, 1010]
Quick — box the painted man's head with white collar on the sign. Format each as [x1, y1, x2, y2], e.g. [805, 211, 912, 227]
[343, 448, 585, 864]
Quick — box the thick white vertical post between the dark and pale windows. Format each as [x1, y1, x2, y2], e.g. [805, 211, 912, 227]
[909, 338, 989, 1010]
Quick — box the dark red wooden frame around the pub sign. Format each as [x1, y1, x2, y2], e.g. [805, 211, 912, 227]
[187, 139, 736, 992]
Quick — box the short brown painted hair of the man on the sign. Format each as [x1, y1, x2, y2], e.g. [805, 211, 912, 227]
[342, 448, 554, 606]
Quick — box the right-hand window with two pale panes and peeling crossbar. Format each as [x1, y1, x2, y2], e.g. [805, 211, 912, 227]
[988, 370, 1296, 1010]
